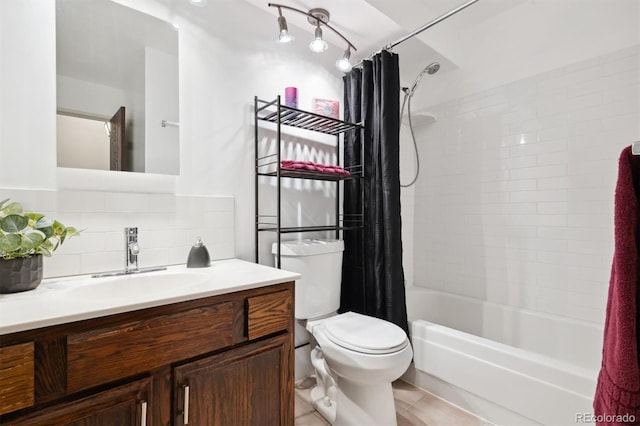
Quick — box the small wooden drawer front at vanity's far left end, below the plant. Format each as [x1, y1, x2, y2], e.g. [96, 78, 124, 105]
[0, 342, 35, 414]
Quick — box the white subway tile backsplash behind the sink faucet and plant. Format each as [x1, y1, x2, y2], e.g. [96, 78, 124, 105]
[0, 188, 235, 278]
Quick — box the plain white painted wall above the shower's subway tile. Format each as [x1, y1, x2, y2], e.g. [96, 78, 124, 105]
[414, 0, 640, 111]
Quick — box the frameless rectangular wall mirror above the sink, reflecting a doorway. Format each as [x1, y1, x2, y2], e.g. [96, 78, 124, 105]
[56, 0, 180, 175]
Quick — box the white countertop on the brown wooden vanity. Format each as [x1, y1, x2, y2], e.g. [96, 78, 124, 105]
[0, 259, 300, 335]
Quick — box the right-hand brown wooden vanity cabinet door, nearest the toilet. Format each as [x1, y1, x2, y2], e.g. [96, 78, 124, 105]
[174, 335, 293, 426]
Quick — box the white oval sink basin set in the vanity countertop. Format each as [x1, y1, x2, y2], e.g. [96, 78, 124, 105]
[52, 271, 209, 300]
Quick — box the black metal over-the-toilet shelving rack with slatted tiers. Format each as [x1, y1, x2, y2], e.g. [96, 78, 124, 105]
[254, 96, 364, 268]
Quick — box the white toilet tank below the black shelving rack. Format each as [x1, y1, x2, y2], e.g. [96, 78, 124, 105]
[272, 240, 344, 319]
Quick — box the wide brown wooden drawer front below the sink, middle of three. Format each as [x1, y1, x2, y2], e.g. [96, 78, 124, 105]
[67, 302, 233, 392]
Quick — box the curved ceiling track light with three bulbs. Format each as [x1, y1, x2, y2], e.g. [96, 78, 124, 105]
[269, 3, 358, 72]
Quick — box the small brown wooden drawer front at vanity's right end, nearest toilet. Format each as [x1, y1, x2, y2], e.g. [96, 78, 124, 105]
[247, 290, 293, 339]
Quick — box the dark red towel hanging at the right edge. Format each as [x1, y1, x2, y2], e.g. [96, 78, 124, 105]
[593, 147, 640, 425]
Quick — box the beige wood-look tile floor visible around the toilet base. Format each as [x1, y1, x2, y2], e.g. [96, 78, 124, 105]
[295, 379, 490, 426]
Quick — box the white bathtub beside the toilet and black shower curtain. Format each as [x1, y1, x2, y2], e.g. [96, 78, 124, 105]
[403, 287, 602, 425]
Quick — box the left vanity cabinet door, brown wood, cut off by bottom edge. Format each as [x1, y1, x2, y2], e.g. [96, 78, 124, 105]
[2, 373, 151, 426]
